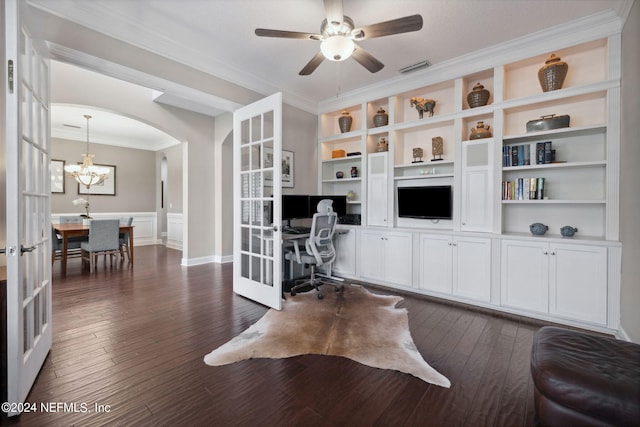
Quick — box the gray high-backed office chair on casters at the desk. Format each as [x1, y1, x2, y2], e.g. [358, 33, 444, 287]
[285, 199, 342, 299]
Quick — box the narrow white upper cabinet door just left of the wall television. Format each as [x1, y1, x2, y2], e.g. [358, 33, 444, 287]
[367, 152, 389, 227]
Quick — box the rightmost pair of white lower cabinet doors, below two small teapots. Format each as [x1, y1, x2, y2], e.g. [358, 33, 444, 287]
[501, 240, 607, 325]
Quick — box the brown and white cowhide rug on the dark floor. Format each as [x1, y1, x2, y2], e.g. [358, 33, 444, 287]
[204, 285, 451, 388]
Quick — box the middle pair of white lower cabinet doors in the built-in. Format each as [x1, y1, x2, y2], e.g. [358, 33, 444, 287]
[418, 234, 491, 302]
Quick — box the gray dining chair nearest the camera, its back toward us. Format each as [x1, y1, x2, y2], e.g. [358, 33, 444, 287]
[81, 219, 120, 271]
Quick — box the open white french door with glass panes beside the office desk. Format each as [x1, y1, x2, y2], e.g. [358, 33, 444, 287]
[233, 93, 282, 310]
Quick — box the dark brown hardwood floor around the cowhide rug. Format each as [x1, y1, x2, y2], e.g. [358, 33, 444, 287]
[3, 246, 540, 426]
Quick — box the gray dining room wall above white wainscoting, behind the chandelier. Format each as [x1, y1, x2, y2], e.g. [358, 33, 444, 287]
[51, 138, 156, 214]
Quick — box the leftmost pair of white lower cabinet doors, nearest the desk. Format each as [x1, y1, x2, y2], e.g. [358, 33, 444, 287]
[358, 229, 413, 286]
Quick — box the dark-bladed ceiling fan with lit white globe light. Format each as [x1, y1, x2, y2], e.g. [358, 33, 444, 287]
[255, 0, 422, 76]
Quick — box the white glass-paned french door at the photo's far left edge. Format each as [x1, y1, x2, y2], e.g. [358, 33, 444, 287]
[0, 0, 52, 415]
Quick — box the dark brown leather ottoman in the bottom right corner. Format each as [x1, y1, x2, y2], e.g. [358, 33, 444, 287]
[531, 326, 640, 426]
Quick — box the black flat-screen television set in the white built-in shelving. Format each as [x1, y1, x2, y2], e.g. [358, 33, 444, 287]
[398, 185, 452, 219]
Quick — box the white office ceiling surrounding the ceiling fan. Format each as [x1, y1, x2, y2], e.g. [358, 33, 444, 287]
[29, 0, 633, 152]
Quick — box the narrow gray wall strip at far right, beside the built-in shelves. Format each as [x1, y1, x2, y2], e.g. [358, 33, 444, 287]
[620, 1, 640, 343]
